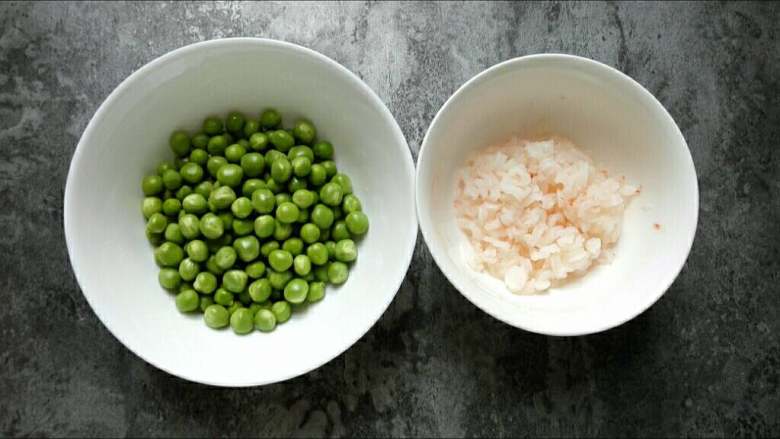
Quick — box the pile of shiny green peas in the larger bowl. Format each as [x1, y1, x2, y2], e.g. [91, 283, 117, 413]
[141, 109, 368, 334]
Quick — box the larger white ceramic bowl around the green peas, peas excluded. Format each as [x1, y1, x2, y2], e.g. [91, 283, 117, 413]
[65, 38, 417, 386]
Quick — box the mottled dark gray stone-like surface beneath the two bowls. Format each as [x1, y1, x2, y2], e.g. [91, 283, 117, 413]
[0, 3, 780, 436]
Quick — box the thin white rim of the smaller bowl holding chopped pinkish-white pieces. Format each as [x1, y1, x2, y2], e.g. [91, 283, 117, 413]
[415, 53, 699, 337]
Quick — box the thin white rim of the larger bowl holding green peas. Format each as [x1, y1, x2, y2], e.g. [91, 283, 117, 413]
[62, 37, 419, 387]
